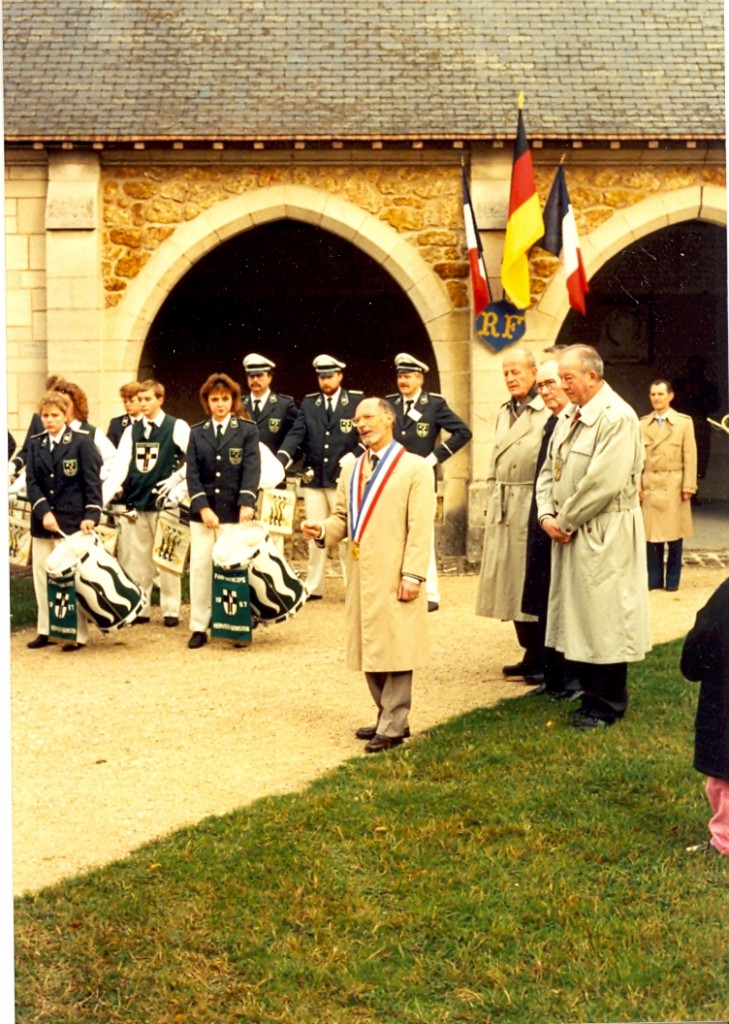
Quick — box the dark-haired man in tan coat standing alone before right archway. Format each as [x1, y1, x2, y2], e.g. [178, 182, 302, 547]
[640, 380, 696, 590]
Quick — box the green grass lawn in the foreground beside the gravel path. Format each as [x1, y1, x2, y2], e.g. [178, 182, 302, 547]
[15, 643, 729, 1024]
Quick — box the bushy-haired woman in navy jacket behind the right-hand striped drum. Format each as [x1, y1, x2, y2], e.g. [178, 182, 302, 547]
[186, 373, 261, 649]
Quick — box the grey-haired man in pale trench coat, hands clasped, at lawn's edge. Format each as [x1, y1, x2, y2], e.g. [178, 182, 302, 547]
[537, 345, 650, 729]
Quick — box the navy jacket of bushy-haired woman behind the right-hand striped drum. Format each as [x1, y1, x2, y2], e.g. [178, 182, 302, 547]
[185, 416, 261, 522]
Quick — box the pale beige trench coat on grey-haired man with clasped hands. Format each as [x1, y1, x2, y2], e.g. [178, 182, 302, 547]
[537, 384, 650, 665]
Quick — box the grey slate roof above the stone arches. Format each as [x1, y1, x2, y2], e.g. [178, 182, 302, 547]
[3, 0, 724, 140]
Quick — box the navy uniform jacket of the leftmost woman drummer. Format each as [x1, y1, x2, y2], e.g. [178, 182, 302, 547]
[26, 428, 101, 538]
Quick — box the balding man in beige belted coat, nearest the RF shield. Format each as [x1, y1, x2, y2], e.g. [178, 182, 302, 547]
[476, 347, 551, 683]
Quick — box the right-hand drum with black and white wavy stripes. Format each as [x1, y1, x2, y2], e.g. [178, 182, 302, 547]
[213, 522, 308, 625]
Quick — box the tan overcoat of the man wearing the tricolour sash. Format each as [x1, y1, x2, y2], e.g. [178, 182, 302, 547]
[324, 452, 435, 672]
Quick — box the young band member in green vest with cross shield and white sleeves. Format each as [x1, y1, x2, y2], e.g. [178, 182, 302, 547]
[103, 380, 189, 628]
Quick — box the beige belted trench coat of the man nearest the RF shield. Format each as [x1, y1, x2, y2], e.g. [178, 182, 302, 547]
[476, 395, 551, 622]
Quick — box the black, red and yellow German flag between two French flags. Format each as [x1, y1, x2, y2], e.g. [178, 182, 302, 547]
[502, 104, 544, 309]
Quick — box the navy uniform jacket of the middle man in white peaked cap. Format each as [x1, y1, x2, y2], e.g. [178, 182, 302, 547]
[277, 388, 365, 487]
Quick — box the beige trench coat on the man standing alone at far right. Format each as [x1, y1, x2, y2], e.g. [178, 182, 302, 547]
[640, 409, 696, 544]
